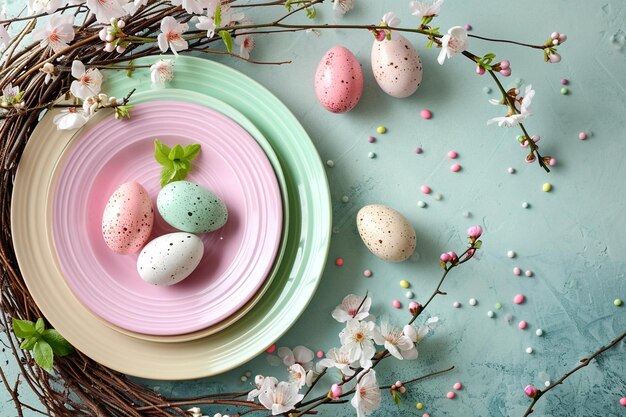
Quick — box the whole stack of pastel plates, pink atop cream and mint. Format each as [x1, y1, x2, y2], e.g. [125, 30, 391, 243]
[12, 57, 330, 380]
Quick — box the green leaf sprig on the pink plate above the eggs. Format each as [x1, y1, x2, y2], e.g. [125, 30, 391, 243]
[154, 139, 200, 187]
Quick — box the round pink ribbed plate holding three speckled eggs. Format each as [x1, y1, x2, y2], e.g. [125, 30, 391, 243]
[52, 101, 282, 335]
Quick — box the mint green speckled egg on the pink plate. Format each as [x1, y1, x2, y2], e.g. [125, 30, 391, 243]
[157, 181, 228, 233]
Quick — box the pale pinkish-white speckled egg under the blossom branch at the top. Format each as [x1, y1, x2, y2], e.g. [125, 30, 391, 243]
[372, 32, 423, 98]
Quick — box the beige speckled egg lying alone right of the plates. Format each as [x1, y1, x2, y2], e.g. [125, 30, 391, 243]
[356, 204, 415, 262]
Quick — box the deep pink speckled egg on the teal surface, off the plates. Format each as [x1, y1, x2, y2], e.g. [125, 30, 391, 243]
[315, 46, 363, 113]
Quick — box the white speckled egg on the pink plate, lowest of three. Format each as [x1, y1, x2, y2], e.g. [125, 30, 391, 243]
[137, 232, 204, 286]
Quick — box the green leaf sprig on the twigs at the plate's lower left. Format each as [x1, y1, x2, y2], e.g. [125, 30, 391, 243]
[13, 318, 74, 372]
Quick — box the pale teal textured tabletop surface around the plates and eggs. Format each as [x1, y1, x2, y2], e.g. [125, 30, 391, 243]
[0, 0, 626, 417]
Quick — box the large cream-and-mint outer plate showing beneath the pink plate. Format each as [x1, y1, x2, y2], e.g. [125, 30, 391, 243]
[11, 57, 331, 380]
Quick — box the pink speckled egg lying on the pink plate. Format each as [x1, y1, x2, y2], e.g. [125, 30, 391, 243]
[102, 181, 154, 255]
